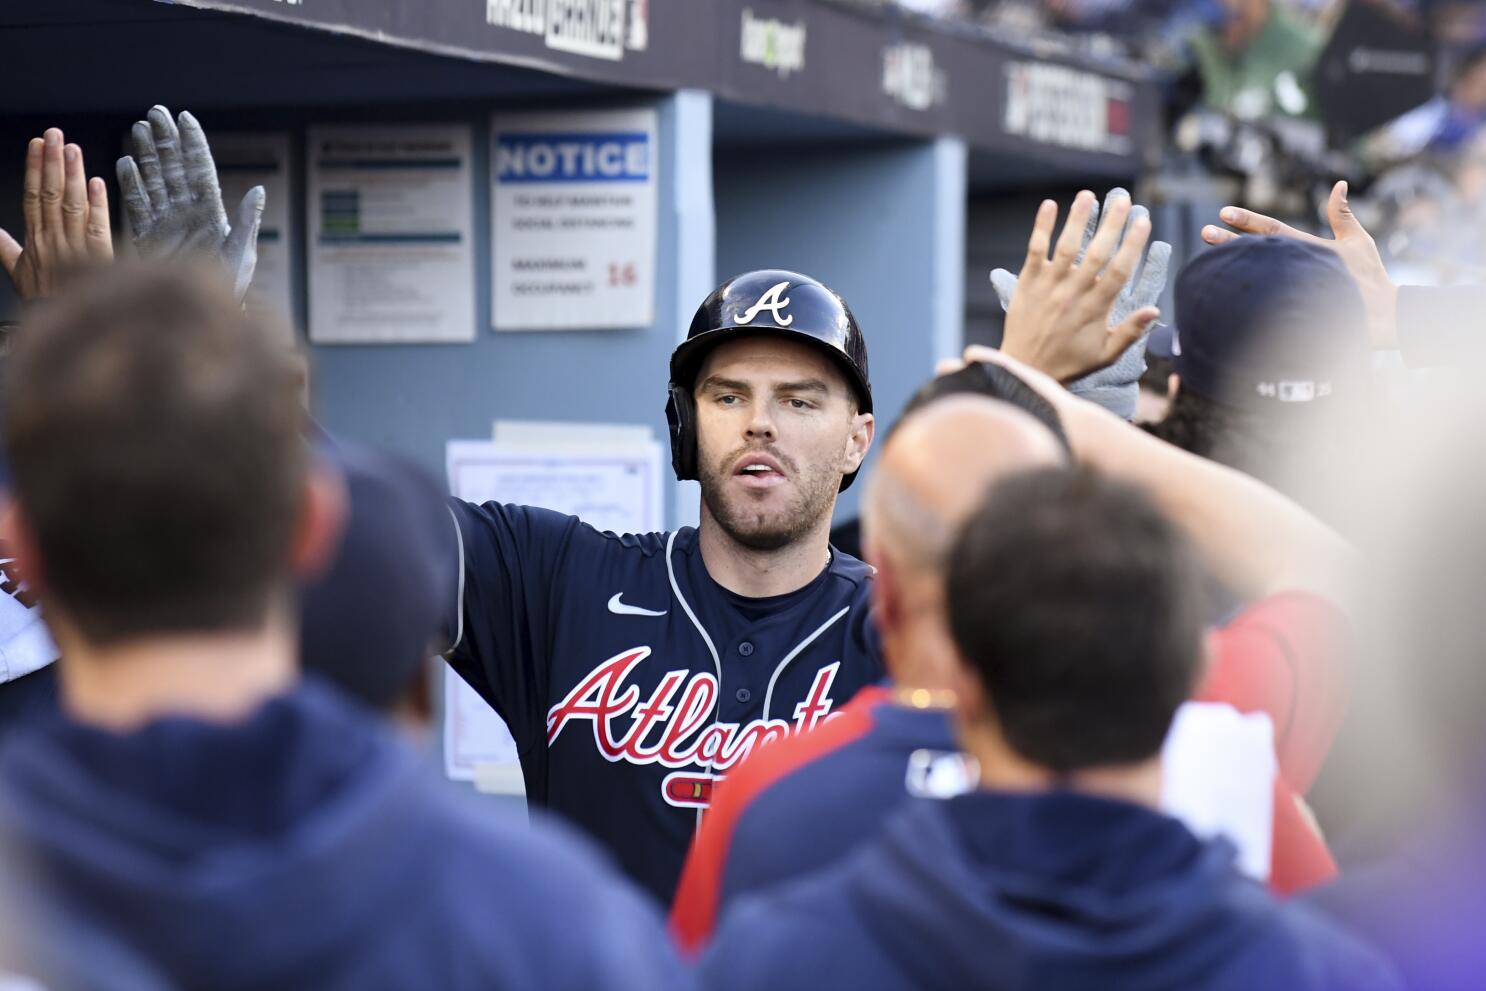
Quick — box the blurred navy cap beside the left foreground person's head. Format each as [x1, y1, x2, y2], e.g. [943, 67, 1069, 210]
[300, 440, 445, 710]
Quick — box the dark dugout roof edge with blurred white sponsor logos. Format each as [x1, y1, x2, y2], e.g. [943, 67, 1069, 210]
[156, 0, 1153, 166]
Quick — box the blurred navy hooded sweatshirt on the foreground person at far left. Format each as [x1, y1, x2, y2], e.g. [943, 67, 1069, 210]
[0, 683, 685, 991]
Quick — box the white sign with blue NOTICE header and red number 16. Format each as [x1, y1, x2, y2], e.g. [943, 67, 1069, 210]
[490, 110, 658, 330]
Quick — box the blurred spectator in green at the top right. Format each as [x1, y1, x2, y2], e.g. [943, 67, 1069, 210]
[1192, 0, 1323, 120]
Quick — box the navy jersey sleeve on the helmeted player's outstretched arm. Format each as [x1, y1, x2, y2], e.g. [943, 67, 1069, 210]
[444, 499, 581, 753]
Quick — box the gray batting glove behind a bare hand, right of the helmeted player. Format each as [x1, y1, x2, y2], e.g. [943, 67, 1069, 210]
[991, 187, 1171, 419]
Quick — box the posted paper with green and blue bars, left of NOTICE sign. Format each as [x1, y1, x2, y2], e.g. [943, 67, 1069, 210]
[306, 123, 476, 343]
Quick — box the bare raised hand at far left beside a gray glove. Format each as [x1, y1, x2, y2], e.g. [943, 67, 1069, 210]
[0, 128, 113, 300]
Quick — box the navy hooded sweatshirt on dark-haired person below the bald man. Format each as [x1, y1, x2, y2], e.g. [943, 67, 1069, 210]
[703, 792, 1397, 991]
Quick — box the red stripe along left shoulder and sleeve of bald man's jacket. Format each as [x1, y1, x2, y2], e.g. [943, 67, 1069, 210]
[670, 688, 887, 954]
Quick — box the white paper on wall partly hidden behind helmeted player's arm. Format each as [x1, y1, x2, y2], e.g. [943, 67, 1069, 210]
[444, 423, 664, 792]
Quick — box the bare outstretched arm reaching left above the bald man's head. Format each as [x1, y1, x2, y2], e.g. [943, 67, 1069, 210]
[964, 348, 1358, 600]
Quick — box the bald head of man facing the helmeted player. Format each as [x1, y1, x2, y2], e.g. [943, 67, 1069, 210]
[862, 395, 1067, 574]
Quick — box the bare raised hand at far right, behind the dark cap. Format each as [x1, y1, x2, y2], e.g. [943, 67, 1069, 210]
[1202, 181, 1398, 348]
